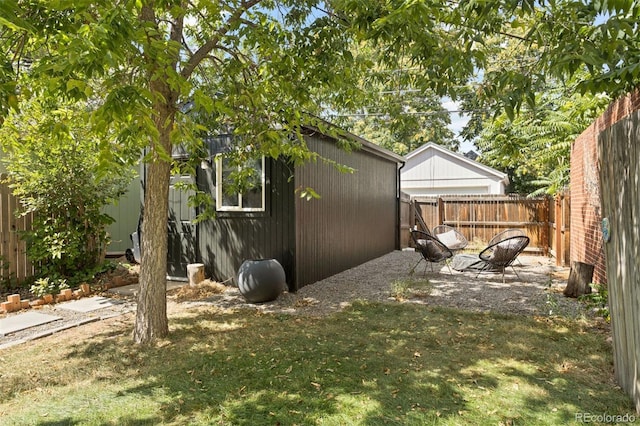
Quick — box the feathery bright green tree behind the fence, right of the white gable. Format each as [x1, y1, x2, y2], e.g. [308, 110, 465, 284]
[475, 85, 610, 195]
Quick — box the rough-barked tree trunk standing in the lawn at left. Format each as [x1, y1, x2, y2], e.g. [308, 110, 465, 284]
[133, 2, 188, 344]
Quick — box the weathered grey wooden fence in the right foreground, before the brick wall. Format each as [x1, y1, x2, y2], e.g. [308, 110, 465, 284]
[598, 112, 640, 412]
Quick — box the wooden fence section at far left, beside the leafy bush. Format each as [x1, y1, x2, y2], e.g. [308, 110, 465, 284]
[0, 176, 33, 282]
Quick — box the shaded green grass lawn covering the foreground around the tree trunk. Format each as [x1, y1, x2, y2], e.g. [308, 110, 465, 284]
[0, 303, 635, 425]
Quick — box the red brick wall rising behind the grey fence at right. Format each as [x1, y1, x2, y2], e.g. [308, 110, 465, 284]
[570, 90, 640, 284]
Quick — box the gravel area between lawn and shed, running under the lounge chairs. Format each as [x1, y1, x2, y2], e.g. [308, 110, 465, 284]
[0, 251, 590, 348]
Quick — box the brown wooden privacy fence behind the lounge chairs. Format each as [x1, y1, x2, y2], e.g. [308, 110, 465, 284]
[401, 195, 570, 265]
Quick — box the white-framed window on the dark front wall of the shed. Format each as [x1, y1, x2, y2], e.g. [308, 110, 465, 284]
[216, 155, 265, 212]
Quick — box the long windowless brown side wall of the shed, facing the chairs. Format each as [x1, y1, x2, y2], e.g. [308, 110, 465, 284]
[295, 131, 398, 287]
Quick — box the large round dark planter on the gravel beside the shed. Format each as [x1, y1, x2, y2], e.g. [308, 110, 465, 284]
[238, 259, 287, 303]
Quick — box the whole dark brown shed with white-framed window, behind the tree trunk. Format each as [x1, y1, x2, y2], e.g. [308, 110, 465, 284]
[154, 123, 403, 291]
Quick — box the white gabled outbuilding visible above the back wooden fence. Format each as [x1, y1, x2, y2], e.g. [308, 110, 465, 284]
[401, 142, 509, 197]
